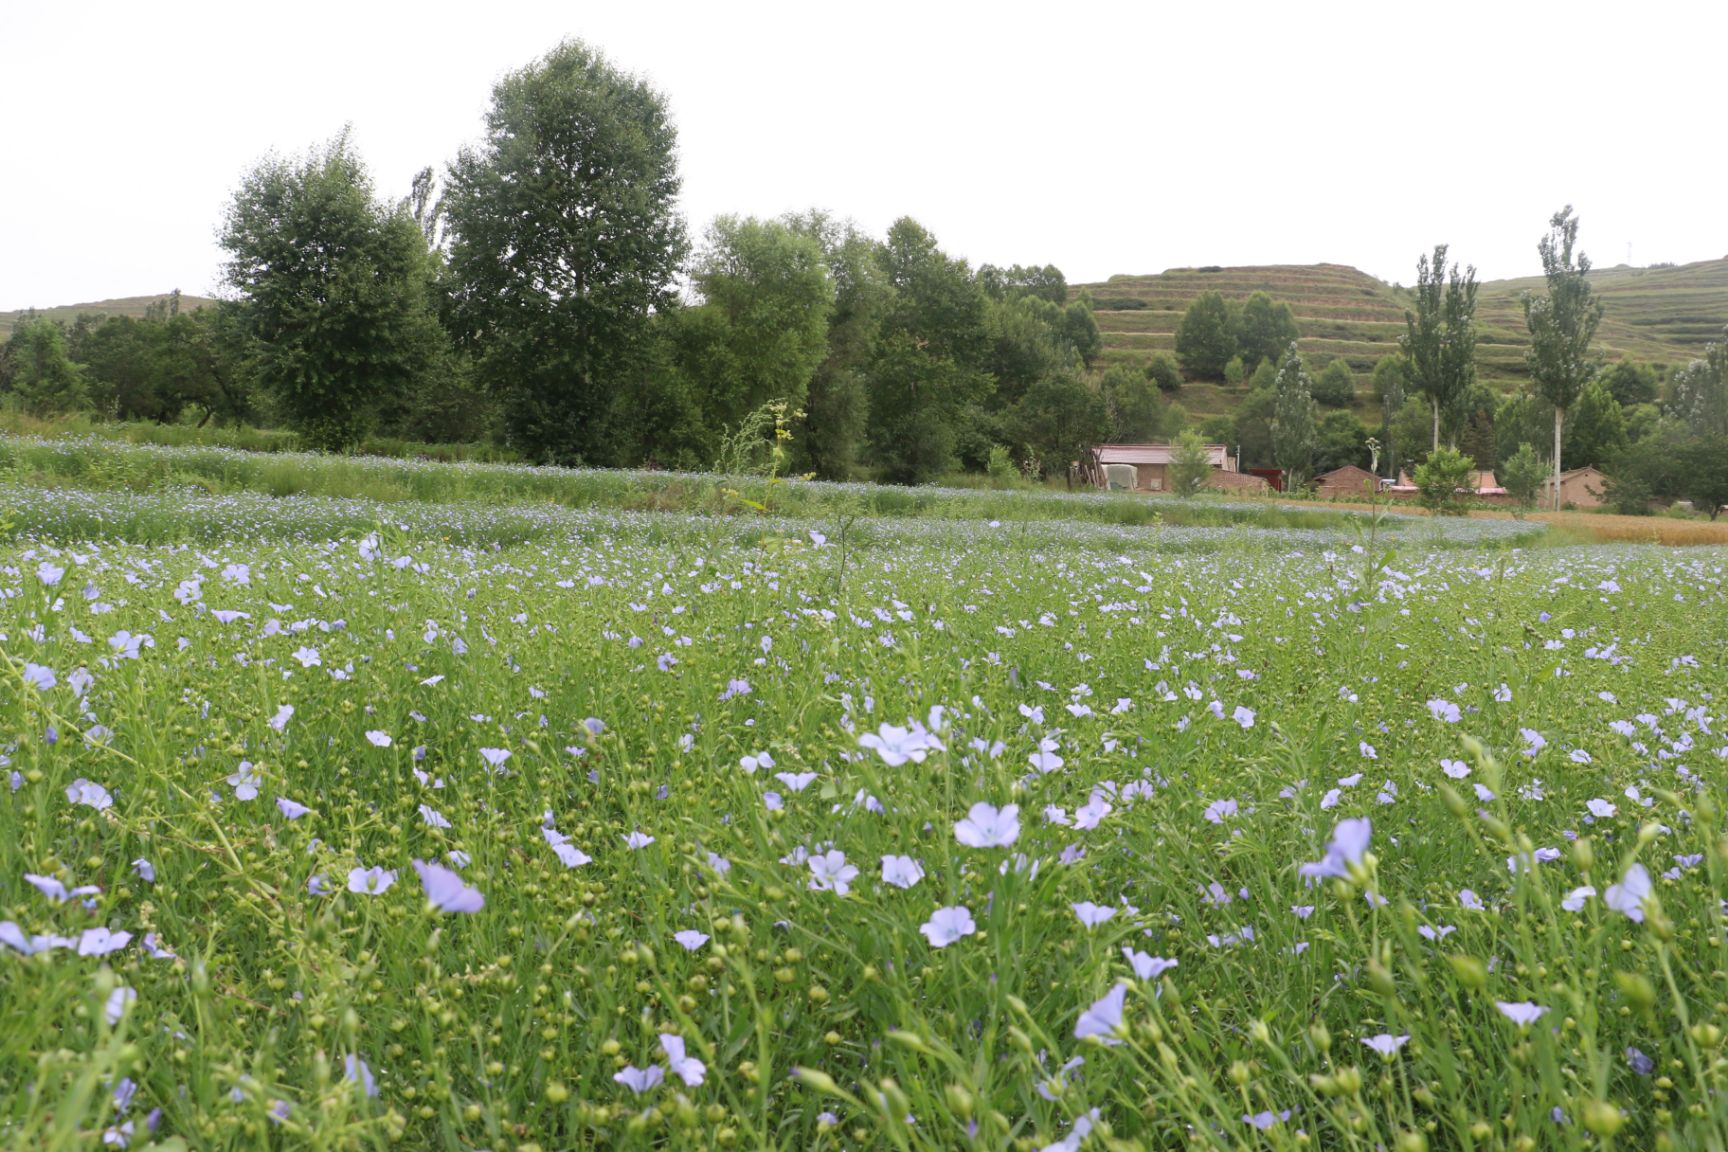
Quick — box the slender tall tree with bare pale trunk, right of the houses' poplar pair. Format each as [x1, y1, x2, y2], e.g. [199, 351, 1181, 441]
[1524, 204, 1602, 511]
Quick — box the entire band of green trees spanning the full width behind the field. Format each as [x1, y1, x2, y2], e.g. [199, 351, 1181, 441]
[0, 41, 1728, 506]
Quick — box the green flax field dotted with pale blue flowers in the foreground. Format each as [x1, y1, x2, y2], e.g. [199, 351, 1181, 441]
[0, 476, 1728, 1152]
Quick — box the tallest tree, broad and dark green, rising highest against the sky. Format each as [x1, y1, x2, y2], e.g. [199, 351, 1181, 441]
[444, 40, 688, 463]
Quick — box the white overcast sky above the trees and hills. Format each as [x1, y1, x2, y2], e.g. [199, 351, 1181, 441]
[0, 0, 1728, 309]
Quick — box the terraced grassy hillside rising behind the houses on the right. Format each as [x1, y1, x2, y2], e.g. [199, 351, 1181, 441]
[1077, 259, 1728, 415]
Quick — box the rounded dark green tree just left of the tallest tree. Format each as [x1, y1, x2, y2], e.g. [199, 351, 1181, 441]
[221, 131, 444, 449]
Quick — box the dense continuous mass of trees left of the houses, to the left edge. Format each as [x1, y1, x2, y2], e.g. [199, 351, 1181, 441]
[0, 41, 1158, 484]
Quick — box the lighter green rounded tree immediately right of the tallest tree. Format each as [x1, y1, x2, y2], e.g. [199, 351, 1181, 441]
[677, 216, 835, 438]
